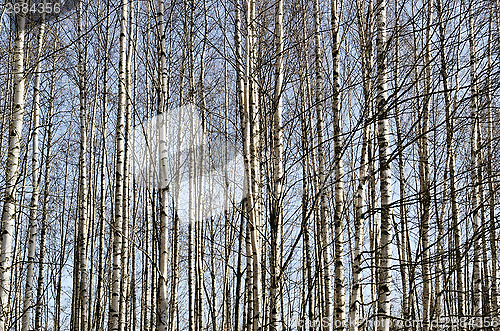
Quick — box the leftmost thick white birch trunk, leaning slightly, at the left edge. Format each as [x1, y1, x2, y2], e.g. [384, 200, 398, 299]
[0, 0, 26, 331]
